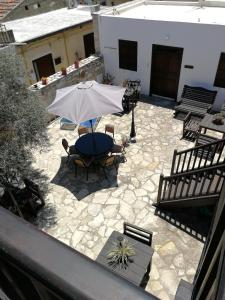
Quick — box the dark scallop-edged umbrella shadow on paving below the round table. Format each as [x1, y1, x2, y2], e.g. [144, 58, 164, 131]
[51, 156, 123, 201]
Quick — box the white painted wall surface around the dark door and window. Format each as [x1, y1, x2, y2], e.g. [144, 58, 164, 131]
[99, 15, 225, 110]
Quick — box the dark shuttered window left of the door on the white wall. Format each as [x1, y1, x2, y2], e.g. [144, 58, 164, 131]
[119, 40, 137, 71]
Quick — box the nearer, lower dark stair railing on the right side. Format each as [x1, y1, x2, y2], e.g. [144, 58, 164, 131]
[157, 164, 225, 204]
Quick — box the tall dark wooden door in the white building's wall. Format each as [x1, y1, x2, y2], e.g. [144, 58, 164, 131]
[150, 45, 183, 99]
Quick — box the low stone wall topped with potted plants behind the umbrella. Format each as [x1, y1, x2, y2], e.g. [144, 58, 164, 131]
[30, 55, 104, 119]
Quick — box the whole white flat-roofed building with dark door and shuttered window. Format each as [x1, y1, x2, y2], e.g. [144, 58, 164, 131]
[95, 1, 225, 110]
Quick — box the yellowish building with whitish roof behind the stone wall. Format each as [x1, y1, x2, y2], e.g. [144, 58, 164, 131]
[5, 7, 95, 85]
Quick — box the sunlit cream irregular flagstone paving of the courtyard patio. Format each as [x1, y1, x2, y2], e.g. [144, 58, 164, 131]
[33, 100, 203, 300]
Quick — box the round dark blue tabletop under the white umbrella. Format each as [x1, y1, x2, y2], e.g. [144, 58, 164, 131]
[75, 132, 113, 156]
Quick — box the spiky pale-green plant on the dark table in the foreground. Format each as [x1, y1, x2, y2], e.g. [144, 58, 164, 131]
[107, 236, 135, 269]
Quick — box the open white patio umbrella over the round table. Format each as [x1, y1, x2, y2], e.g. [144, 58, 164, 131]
[47, 80, 126, 131]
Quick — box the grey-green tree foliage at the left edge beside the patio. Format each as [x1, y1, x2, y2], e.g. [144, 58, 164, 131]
[0, 50, 47, 186]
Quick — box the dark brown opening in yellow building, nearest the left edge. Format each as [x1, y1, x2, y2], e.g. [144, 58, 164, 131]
[33, 54, 55, 80]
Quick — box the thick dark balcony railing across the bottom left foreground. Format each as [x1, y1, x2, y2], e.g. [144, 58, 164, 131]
[0, 207, 158, 300]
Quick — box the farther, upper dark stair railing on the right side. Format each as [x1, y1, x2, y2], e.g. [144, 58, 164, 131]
[171, 139, 225, 175]
